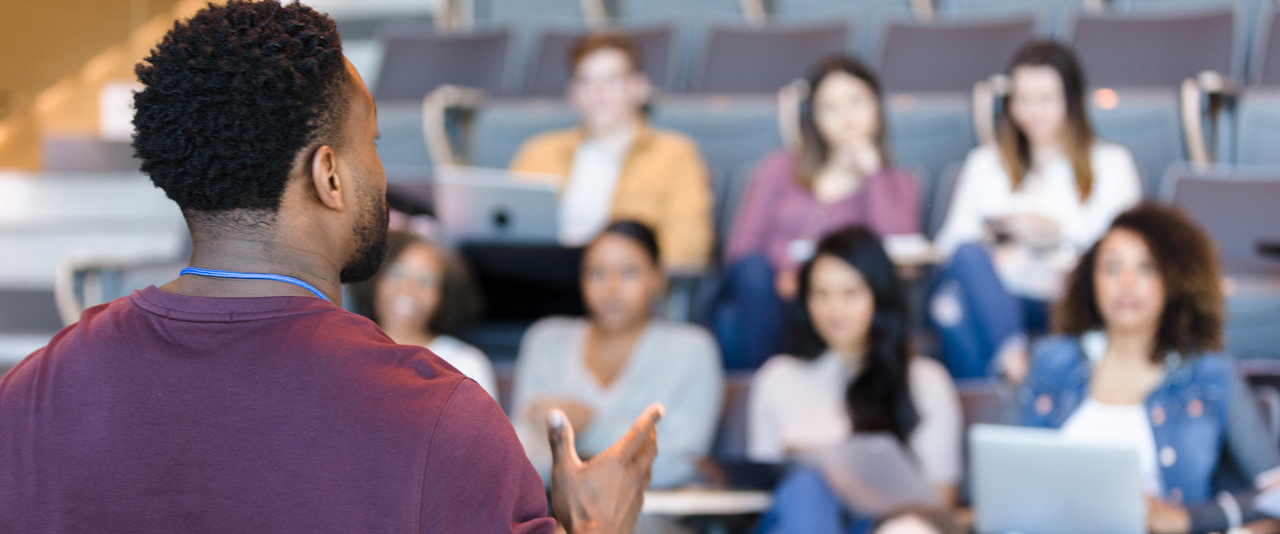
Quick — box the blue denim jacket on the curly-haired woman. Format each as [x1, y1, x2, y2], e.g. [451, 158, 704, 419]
[1019, 333, 1280, 530]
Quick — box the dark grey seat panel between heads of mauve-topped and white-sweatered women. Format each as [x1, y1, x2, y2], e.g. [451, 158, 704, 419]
[878, 18, 1036, 92]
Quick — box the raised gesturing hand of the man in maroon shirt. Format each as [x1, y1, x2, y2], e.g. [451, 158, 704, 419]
[547, 403, 666, 534]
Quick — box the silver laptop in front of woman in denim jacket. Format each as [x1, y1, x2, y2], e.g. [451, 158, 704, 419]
[969, 425, 1147, 534]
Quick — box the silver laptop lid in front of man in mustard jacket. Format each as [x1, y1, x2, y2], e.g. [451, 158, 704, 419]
[434, 165, 559, 245]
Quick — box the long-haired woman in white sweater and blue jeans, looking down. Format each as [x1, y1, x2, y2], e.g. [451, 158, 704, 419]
[929, 42, 1142, 382]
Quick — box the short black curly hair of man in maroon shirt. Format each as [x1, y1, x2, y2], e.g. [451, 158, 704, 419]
[133, 0, 349, 216]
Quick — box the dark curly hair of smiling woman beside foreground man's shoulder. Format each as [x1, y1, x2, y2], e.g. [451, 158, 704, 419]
[351, 231, 484, 336]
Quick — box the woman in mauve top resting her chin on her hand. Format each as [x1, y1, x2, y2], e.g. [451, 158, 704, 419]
[712, 58, 920, 368]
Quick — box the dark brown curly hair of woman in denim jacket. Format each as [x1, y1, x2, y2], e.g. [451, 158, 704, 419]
[1056, 202, 1224, 361]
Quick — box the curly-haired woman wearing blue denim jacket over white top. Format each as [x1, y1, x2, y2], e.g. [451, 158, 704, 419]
[1019, 204, 1280, 533]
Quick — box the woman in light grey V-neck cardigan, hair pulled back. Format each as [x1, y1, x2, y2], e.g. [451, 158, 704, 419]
[512, 222, 723, 488]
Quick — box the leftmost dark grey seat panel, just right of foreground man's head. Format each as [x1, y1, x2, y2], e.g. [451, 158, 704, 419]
[374, 24, 512, 100]
